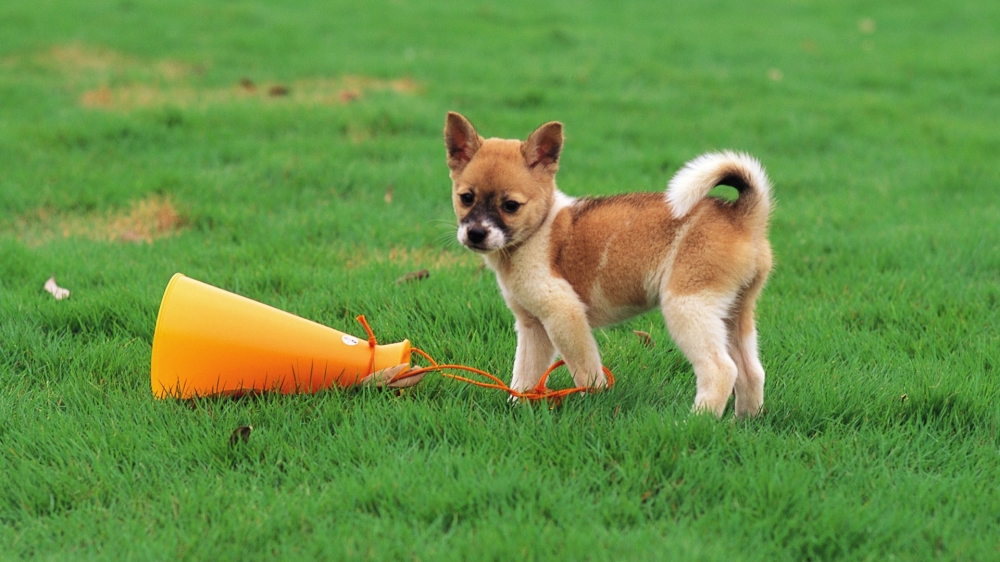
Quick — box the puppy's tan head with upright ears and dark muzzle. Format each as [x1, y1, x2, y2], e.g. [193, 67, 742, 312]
[444, 112, 563, 253]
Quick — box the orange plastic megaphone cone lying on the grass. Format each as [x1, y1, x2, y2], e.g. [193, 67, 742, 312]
[150, 273, 420, 398]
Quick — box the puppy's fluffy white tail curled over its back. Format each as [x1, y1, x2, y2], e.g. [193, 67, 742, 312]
[667, 150, 771, 222]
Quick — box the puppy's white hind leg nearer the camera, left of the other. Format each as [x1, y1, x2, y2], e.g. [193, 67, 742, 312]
[661, 291, 737, 417]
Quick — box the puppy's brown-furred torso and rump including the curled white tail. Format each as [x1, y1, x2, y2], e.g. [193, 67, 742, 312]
[550, 153, 771, 326]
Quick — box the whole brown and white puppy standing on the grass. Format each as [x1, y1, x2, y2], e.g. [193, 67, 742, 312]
[444, 113, 771, 416]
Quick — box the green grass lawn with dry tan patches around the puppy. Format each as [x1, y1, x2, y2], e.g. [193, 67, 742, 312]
[0, 0, 1000, 560]
